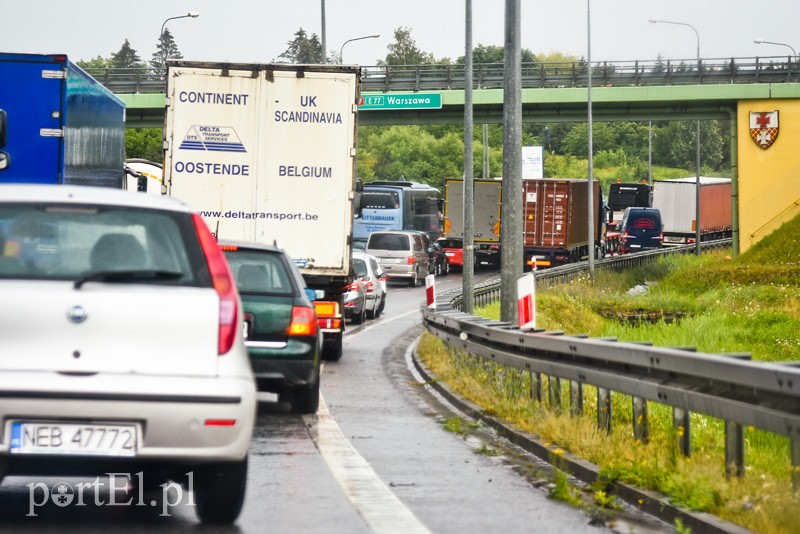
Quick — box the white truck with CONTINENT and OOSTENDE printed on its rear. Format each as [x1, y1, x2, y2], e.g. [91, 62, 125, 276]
[164, 61, 361, 359]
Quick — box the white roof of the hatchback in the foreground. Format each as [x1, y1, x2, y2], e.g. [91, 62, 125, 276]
[0, 184, 194, 212]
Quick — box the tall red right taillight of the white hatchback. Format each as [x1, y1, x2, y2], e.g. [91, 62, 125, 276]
[192, 213, 239, 355]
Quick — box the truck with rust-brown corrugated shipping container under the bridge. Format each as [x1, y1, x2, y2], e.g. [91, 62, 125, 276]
[522, 178, 605, 268]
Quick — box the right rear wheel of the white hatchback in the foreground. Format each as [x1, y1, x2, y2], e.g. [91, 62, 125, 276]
[193, 458, 247, 525]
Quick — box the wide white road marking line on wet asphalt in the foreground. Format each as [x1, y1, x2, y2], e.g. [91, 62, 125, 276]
[303, 394, 430, 534]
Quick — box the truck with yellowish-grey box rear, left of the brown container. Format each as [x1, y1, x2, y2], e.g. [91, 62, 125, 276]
[444, 178, 503, 266]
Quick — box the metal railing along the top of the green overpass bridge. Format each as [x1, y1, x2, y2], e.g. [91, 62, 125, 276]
[86, 56, 800, 94]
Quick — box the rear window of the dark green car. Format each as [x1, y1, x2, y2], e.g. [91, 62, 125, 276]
[225, 249, 297, 295]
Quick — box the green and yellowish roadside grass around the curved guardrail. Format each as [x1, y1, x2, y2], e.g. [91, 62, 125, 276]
[419, 213, 800, 533]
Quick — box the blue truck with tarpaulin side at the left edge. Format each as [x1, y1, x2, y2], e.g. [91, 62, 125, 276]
[0, 53, 125, 189]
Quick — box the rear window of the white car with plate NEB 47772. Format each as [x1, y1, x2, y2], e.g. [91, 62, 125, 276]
[0, 203, 210, 286]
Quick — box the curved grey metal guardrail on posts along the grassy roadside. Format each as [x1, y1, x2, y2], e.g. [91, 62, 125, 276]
[422, 239, 800, 491]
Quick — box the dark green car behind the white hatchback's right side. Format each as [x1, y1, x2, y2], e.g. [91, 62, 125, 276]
[219, 242, 322, 414]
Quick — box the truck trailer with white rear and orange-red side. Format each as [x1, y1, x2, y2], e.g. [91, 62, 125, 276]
[653, 176, 733, 246]
